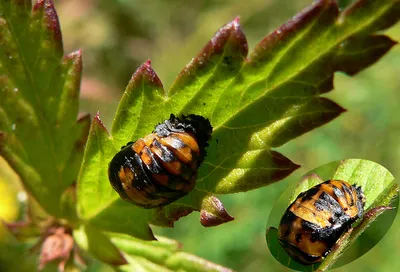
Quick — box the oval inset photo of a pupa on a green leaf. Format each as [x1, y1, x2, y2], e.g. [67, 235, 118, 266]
[266, 159, 399, 271]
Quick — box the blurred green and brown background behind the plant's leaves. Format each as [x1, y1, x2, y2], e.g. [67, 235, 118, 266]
[0, 0, 400, 271]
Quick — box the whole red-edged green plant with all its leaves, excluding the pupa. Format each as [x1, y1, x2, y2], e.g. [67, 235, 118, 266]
[0, 0, 400, 271]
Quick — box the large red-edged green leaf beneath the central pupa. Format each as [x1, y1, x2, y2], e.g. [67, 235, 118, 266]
[78, 0, 400, 236]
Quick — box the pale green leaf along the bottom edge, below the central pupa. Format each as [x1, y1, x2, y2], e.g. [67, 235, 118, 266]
[110, 233, 232, 272]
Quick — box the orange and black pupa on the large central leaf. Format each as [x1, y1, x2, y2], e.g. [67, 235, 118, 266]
[108, 114, 212, 208]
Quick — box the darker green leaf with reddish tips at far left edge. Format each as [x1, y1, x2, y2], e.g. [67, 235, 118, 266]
[0, 0, 90, 218]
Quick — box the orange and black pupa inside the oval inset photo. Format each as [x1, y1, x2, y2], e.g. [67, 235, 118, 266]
[278, 180, 365, 265]
